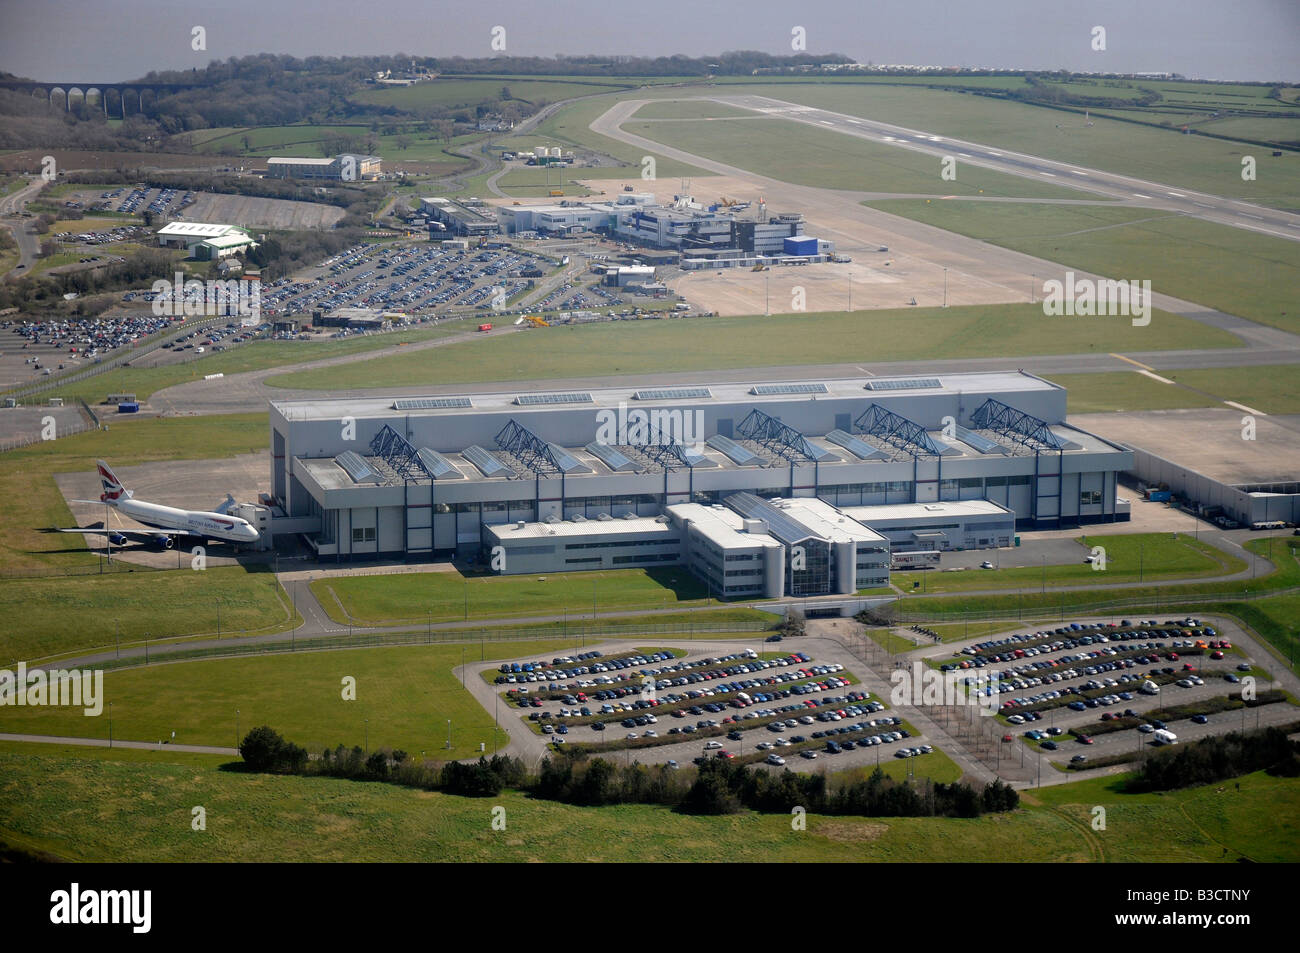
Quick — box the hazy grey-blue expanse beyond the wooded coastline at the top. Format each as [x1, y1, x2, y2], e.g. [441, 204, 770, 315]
[0, 0, 1300, 82]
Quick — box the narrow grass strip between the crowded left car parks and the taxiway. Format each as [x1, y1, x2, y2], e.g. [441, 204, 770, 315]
[49, 321, 472, 404]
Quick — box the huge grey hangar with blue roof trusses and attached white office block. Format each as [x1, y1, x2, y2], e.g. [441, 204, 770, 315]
[270, 372, 1134, 597]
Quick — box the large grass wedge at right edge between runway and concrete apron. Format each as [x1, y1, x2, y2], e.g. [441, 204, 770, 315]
[867, 199, 1300, 333]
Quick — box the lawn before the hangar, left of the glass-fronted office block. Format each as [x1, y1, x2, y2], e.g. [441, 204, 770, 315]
[312, 568, 709, 625]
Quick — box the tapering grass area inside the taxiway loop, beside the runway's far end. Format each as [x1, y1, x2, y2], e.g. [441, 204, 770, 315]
[623, 116, 1088, 199]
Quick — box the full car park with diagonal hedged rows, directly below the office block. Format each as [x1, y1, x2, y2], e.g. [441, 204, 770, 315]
[481, 639, 933, 770]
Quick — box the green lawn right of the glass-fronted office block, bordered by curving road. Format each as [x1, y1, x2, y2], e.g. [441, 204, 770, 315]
[889, 533, 1247, 593]
